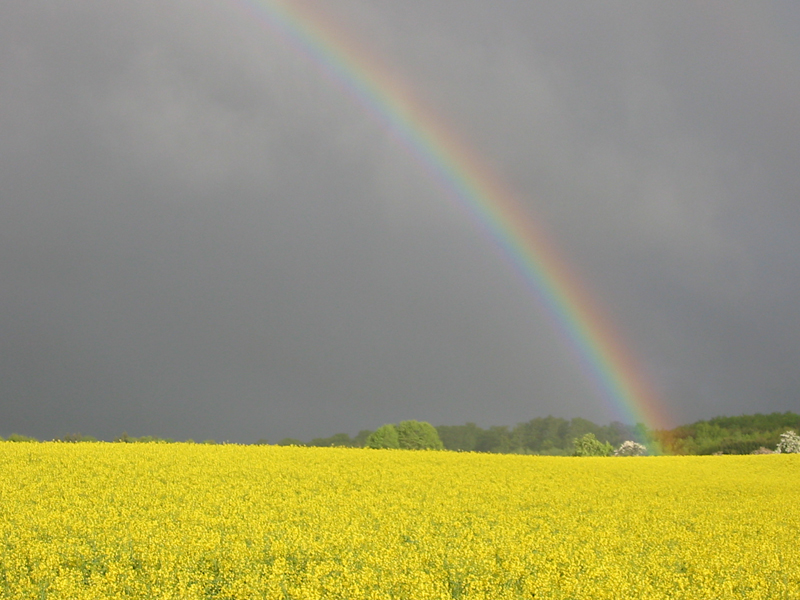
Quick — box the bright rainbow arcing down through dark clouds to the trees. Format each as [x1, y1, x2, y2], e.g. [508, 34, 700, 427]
[231, 0, 669, 428]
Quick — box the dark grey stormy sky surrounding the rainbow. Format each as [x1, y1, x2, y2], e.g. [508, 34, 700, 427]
[0, 0, 800, 442]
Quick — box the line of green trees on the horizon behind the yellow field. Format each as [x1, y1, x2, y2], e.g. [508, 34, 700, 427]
[0, 412, 800, 456]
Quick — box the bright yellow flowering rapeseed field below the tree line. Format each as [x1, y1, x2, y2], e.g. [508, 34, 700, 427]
[0, 443, 800, 600]
